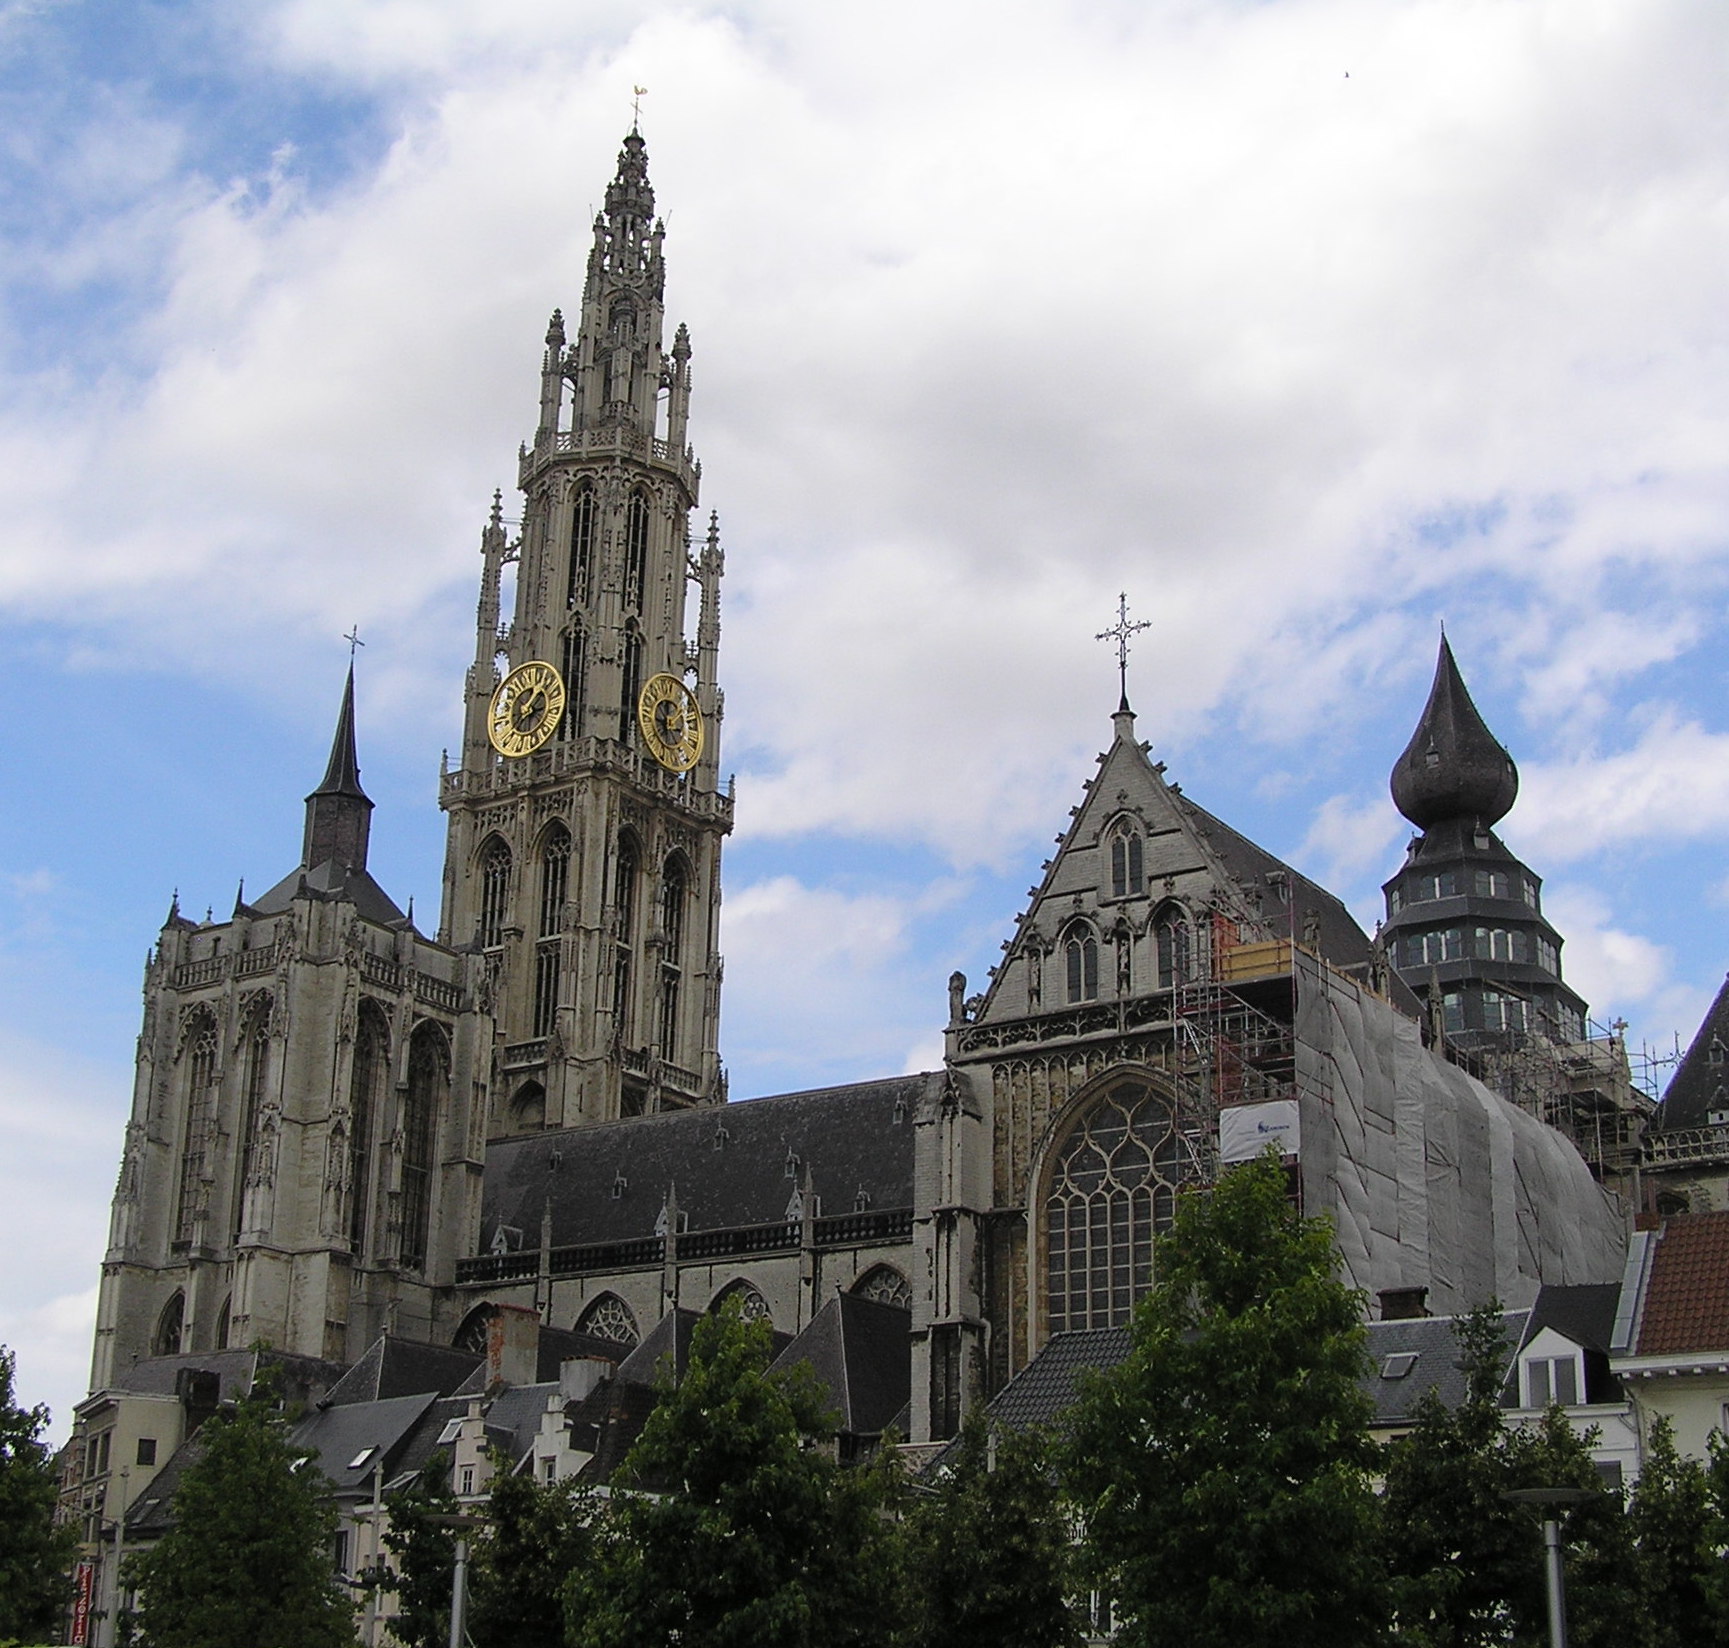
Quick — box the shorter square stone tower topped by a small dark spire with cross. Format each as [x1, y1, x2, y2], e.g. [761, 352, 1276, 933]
[92, 671, 491, 1390]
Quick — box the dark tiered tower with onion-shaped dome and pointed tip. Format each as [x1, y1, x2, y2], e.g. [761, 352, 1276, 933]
[1381, 636, 1585, 1048]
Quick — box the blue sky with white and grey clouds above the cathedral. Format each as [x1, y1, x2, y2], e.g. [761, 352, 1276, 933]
[0, 0, 1729, 1434]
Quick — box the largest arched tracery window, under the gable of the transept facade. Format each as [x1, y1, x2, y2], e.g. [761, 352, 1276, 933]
[1044, 1076, 1202, 1333]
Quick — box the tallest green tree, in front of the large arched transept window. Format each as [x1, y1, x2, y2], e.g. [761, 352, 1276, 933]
[1067, 1153, 1381, 1648]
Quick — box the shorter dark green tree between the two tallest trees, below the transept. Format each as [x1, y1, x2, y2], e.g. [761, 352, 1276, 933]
[906, 1408, 1081, 1648]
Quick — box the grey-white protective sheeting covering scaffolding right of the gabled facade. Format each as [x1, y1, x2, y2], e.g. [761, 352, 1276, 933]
[1297, 953, 1627, 1314]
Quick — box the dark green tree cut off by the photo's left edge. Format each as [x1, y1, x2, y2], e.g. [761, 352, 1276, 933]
[0, 1345, 78, 1641]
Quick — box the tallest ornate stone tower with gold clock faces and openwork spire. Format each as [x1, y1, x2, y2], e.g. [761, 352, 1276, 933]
[441, 130, 731, 1136]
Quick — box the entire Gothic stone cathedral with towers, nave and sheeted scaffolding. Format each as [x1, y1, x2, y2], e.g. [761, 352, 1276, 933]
[92, 131, 1639, 1461]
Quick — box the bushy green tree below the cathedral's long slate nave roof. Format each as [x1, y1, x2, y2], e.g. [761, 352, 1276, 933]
[565, 1307, 901, 1648]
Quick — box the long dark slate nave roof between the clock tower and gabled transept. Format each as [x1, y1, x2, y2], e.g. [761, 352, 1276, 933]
[481, 1072, 944, 1252]
